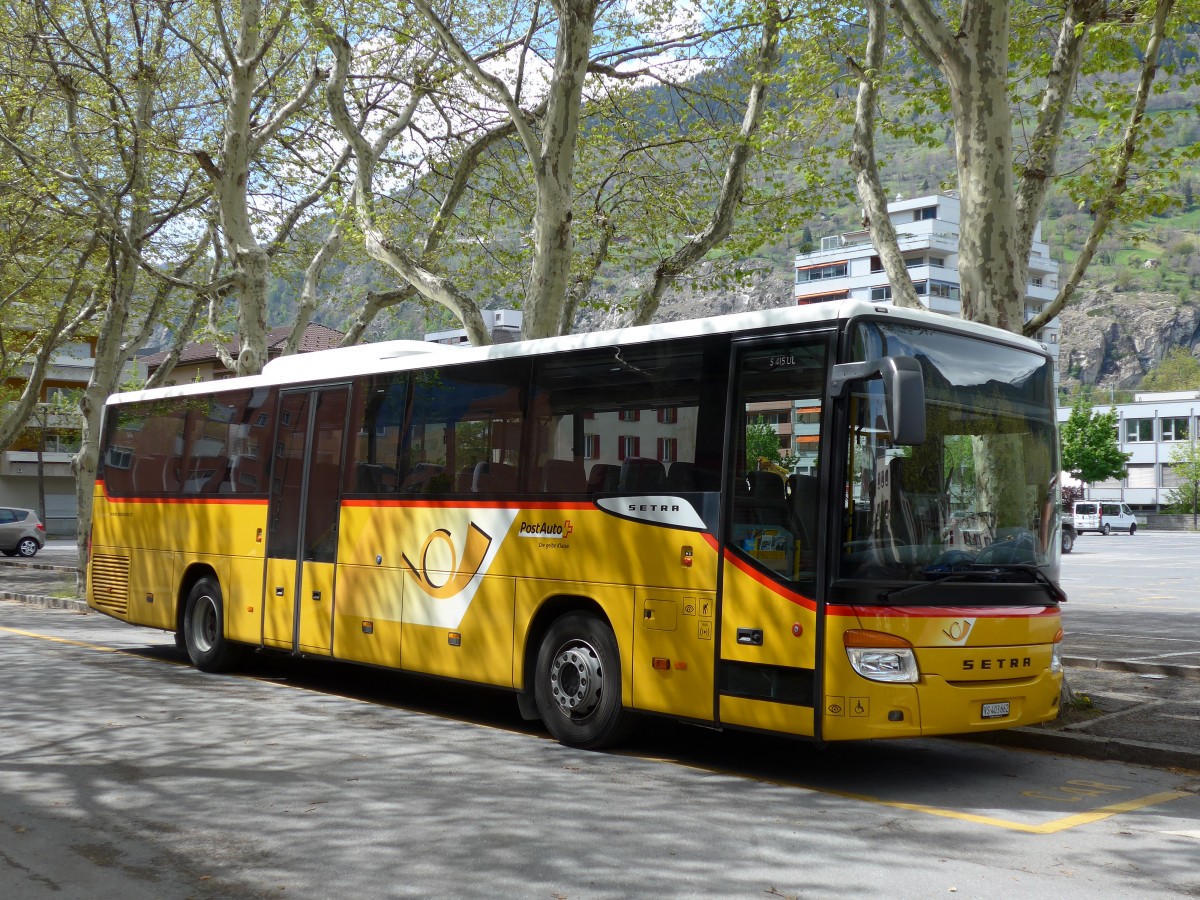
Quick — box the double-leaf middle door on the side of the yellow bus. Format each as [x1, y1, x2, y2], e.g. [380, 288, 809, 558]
[263, 386, 349, 655]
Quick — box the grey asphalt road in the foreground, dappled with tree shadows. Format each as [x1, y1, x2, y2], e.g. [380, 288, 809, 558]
[0, 602, 1200, 900]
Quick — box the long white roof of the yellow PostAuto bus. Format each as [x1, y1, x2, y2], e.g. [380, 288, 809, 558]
[108, 300, 1045, 403]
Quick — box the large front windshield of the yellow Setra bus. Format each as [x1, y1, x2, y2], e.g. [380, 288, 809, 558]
[839, 322, 1060, 593]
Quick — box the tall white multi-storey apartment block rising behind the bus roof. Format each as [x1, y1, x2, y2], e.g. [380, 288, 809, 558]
[796, 191, 1058, 361]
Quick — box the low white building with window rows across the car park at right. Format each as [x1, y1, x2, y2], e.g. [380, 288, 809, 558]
[1058, 391, 1200, 512]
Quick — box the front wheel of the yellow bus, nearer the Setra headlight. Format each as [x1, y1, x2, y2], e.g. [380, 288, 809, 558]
[534, 612, 636, 750]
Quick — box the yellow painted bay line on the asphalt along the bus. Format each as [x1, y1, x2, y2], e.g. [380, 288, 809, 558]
[7, 625, 1200, 839]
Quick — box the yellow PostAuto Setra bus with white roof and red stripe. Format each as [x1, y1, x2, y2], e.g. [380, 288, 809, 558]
[89, 301, 1066, 748]
